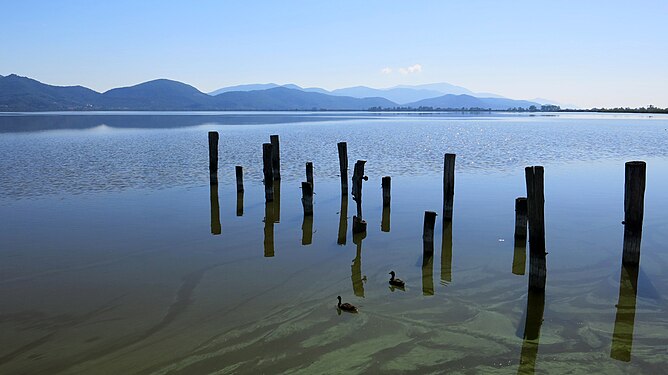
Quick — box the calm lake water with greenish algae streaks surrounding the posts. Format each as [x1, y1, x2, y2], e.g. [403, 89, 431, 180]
[0, 112, 668, 374]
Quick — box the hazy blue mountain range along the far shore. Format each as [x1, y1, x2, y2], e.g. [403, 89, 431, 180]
[0, 74, 560, 112]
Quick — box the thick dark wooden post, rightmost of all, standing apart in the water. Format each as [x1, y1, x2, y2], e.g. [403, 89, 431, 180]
[622, 161, 647, 265]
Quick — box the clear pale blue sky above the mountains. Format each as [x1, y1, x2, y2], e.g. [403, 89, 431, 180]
[0, 0, 668, 108]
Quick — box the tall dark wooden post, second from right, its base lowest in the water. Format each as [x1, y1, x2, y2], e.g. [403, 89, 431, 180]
[524, 166, 547, 291]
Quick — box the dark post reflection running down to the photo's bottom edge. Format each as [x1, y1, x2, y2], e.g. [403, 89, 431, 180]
[517, 289, 545, 374]
